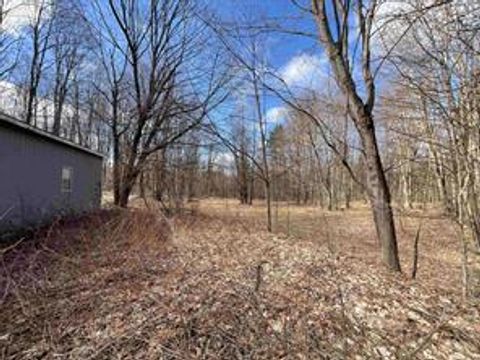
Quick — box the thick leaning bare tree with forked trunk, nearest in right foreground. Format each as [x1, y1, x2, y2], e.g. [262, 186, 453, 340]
[311, 0, 401, 271]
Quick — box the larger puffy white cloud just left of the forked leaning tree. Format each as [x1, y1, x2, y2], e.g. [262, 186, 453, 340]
[280, 53, 328, 89]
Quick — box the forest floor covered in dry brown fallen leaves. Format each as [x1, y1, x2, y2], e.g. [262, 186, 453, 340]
[0, 199, 480, 359]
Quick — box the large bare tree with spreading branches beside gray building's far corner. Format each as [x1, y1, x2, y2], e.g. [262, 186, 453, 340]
[95, 0, 232, 206]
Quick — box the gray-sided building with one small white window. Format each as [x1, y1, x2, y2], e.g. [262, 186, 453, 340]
[0, 113, 103, 234]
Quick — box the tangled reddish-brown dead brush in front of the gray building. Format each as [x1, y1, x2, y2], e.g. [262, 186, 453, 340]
[0, 209, 172, 357]
